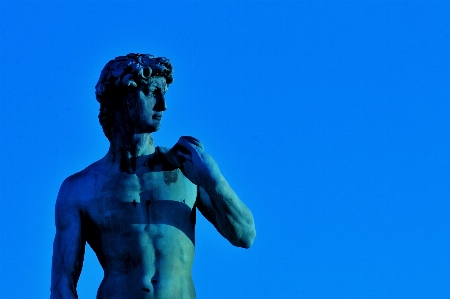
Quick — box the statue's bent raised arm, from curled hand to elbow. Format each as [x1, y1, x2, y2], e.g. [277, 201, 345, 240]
[166, 137, 256, 248]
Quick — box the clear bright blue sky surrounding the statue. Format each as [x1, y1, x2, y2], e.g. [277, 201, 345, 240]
[0, 1, 450, 299]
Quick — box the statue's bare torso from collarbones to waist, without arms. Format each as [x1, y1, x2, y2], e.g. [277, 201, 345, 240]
[77, 149, 197, 299]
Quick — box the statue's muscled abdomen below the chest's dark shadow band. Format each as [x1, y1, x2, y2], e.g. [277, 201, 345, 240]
[93, 224, 195, 299]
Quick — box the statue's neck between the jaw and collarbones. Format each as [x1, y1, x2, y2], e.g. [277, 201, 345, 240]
[107, 133, 155, 173]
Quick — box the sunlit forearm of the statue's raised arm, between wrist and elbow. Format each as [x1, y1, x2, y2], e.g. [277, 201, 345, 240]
[204, 175, 256, 248]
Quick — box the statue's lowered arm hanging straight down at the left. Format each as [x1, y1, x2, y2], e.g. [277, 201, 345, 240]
[50, 178, 86, 299]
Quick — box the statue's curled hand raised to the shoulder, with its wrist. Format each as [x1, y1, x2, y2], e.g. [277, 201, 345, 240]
[165, 136, 221, 189]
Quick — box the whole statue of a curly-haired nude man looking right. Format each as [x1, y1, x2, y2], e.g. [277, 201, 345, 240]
[51, 54, 255, 299]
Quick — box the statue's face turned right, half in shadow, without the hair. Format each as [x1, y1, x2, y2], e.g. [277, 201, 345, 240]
[129, 77, 167, 133]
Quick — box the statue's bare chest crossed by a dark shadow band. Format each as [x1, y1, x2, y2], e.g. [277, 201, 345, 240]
[86, 169, 197, 245]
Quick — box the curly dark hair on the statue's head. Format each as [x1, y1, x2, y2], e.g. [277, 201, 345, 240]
[95, 53, 173, 140]
